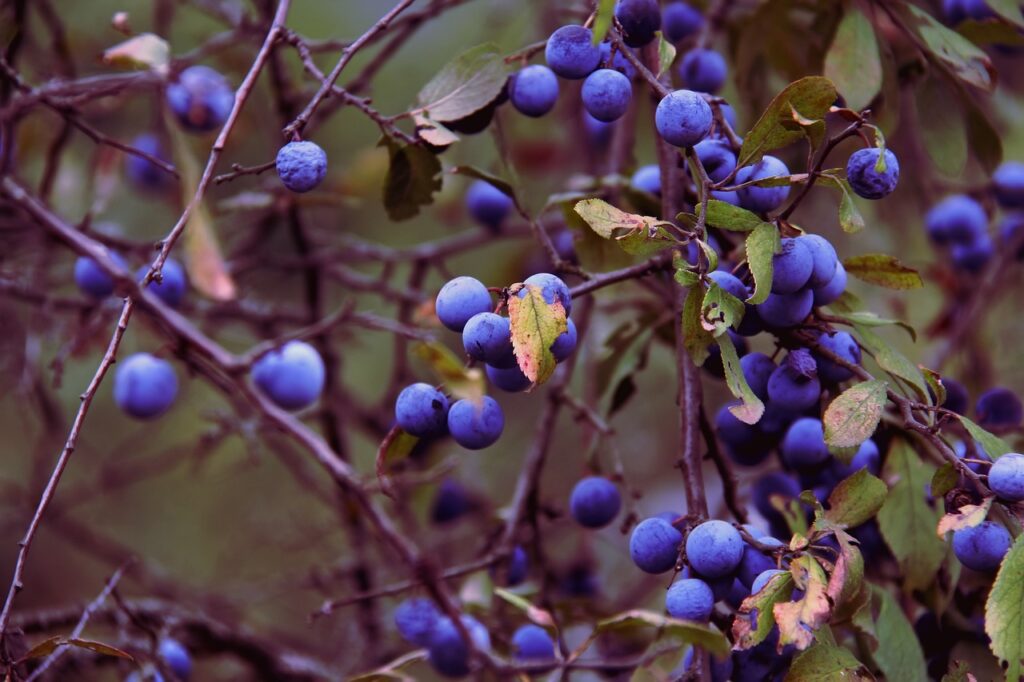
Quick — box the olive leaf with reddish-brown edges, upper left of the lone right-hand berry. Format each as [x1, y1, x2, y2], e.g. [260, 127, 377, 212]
[737, 76, 836, 166]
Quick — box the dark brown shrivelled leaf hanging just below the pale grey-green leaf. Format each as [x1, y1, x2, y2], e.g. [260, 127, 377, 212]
[381, 137, 441, 221]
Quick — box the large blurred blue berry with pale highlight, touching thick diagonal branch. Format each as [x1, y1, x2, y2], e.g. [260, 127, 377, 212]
[253, 341, 327, 410]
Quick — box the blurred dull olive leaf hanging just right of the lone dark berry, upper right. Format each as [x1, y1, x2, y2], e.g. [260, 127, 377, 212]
[914, 76, 968, 178]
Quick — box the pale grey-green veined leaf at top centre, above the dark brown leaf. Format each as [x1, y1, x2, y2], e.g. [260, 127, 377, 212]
[419, 43, 508, 123]
